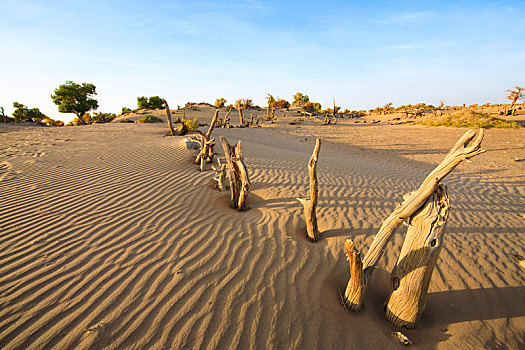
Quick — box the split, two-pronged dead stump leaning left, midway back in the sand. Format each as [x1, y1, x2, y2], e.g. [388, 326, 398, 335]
[221, 136, 250, 211]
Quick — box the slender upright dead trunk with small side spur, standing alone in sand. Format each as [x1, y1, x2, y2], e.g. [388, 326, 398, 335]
[297, 139, 321, 242]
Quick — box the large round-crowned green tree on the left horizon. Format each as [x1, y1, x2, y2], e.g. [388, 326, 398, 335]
[51, 80, 98, 124]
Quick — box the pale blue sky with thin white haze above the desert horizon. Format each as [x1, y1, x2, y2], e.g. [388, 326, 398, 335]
[0, 0, 525, 119]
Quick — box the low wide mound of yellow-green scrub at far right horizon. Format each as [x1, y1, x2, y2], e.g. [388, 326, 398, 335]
[416, 110, 521, 129]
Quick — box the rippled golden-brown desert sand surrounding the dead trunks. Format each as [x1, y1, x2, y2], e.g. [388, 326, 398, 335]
[0, 108, 525, 349]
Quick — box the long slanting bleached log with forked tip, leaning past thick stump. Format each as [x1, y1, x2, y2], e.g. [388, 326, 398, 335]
[344, 129, 485, 311]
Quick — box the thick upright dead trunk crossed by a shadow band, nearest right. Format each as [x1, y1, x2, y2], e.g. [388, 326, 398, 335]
[386, 185, 450, 328]
